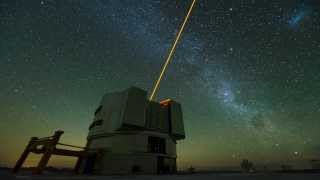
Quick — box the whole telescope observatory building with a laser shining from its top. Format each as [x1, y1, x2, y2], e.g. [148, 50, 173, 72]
[79, 87, 185, 174]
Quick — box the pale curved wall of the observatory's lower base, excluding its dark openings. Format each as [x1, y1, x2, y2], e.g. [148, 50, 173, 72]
[82, 131, 176, 174]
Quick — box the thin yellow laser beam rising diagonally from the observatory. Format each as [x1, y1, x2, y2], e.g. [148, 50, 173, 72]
[149, 0, 196, 101]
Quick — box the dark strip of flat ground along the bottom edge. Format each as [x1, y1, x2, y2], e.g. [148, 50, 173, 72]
[0, 171, 320, 180]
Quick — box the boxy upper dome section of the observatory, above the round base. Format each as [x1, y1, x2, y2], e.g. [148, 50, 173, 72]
[89, 87, 185, 140]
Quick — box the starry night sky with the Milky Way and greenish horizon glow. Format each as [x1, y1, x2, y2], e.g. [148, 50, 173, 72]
[0, 0, 320, 169]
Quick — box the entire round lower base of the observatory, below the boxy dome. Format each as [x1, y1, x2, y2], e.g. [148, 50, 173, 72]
[81, 131, 177, 175]
